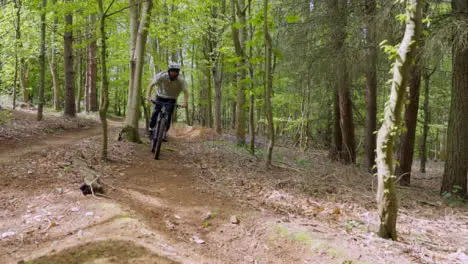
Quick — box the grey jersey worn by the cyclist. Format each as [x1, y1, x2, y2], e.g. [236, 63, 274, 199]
[153, 71, 187, 99]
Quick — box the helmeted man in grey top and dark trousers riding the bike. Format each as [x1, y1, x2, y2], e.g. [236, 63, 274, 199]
[146, 64, 188, 141]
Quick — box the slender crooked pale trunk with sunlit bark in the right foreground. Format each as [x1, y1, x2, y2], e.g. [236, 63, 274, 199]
[376, 0, 421, 240]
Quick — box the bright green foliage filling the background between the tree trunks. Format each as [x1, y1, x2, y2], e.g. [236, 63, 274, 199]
[0, 0, 458, 171]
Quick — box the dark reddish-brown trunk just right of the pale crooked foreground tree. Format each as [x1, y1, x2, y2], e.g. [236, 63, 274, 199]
[395, 66, 421, 186]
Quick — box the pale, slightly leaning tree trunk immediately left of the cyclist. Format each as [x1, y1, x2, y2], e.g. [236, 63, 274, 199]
[123, 1, 153, 142]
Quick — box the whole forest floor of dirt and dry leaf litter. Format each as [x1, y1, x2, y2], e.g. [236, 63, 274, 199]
[0, 108, 468, 263]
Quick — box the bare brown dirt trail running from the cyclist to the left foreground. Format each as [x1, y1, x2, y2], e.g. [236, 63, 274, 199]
[0, 121, 326, 263]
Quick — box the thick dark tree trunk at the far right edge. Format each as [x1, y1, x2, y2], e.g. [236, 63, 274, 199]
[440, 0, 468, 196]
